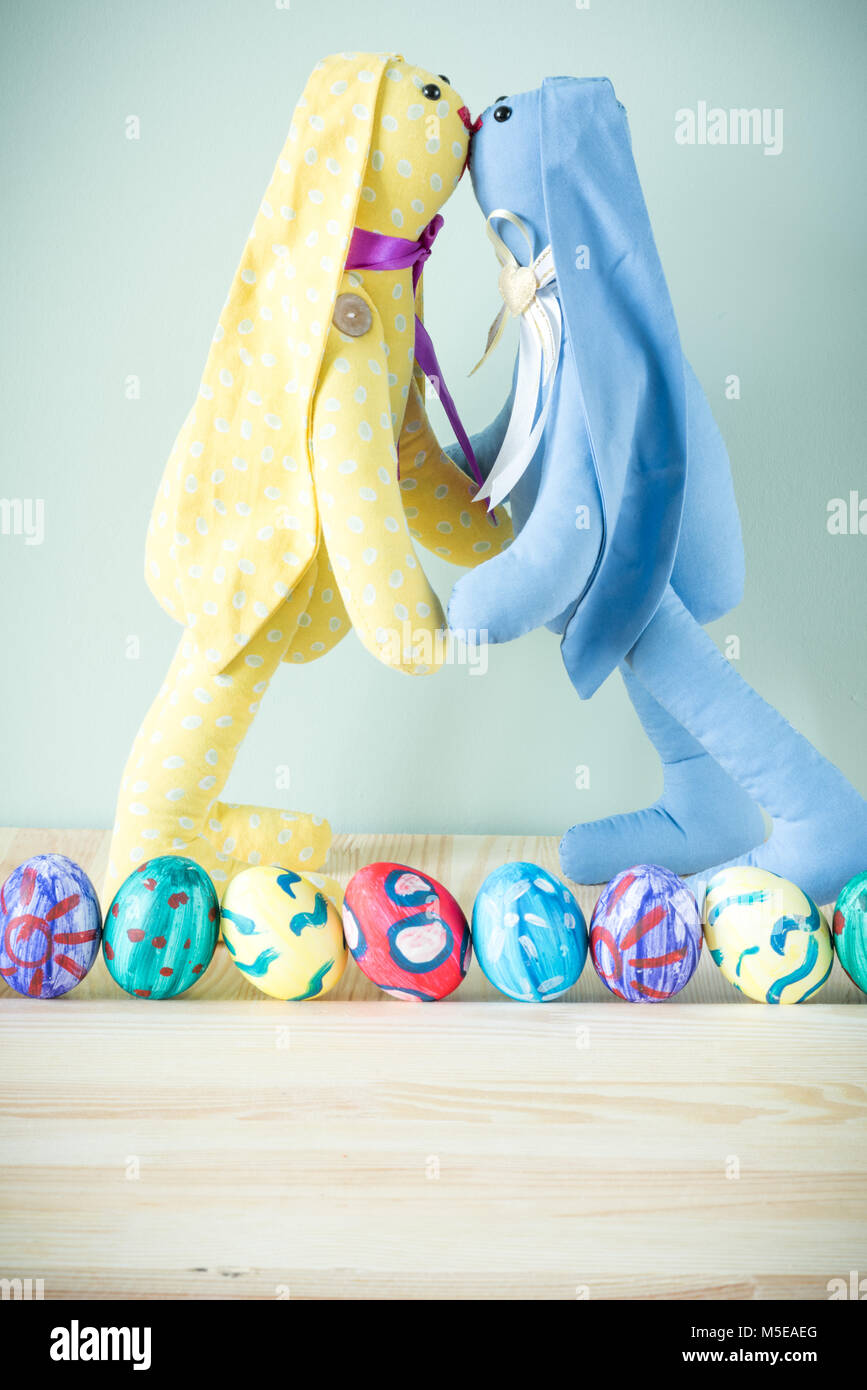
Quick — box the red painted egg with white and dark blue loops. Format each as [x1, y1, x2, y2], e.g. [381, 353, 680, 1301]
[343, 863, 472, 1001]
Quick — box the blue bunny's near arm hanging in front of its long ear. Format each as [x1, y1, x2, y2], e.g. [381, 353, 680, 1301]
[449, 367, 602, 642]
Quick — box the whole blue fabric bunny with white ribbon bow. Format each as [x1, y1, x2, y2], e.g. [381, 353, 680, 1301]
[449, 78, 867, 902]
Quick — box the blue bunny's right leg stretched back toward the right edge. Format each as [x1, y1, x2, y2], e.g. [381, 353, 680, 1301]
[627, 588, 867, 904]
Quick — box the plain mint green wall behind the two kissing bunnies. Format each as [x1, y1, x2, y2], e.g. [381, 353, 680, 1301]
[0, 0, 867, 833]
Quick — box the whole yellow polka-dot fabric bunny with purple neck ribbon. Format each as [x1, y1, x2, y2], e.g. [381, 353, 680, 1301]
[106, 53, 511, 897]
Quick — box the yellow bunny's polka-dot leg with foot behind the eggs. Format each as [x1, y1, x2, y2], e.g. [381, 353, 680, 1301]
[104, 582, 331, 901]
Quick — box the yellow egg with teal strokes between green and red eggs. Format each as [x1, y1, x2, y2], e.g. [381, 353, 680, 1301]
[221, 865, 346, 999]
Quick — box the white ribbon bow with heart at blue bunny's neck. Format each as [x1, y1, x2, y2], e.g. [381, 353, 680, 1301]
[470, 207, 563, 510]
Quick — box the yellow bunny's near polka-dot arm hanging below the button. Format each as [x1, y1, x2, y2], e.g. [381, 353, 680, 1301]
[313, 323, 445, 674]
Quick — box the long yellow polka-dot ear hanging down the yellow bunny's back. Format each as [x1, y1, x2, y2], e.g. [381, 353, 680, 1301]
[146, 53, 390, 670]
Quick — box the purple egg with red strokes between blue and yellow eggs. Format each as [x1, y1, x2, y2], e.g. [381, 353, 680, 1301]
[591, 865, 702, 1004]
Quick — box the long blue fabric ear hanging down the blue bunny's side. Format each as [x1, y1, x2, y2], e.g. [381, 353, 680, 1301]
[539, 78, 686, 698]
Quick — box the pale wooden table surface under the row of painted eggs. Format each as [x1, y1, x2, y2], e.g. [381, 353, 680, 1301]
[0, 830, 867, 1298]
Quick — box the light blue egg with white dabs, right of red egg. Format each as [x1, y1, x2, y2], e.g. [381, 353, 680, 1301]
[472, 862, 588, 1004]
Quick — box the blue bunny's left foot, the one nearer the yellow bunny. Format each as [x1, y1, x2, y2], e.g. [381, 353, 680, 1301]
[560, 753, 764, 883]
